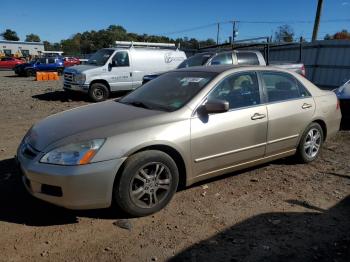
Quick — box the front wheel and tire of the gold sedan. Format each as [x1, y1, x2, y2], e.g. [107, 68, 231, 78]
[113, 150, 179, 217]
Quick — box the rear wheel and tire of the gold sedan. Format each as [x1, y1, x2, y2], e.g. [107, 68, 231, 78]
[296, 122, 324, 163]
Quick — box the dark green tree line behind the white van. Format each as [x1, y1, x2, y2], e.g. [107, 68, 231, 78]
[44, 25, 215, 55]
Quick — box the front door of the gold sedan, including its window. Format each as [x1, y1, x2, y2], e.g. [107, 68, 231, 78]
[191, 71, 267, 176]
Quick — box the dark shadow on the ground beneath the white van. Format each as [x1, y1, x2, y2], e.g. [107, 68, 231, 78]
[32, 90, 128, 102]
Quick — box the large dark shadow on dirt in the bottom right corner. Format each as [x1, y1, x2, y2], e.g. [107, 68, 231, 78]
[170, 196, 350, 262]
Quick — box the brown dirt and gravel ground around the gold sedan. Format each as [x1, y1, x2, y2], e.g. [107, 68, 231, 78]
[0, 71, 350, 261]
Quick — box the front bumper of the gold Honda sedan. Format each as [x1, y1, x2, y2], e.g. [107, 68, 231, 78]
[17, 146, 125, 209]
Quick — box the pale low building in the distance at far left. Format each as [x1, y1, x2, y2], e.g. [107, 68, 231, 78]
[0, 40, 44, 57]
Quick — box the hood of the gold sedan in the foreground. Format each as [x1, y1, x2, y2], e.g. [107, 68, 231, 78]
[27, 100, 166, 151]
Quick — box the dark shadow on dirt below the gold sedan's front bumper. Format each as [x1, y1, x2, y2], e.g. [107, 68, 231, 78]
[0, 158, 126, 226]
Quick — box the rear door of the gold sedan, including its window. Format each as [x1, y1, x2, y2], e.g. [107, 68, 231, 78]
[260, 71, 315, 155]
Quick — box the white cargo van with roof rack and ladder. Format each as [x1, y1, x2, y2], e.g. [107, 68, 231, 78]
[63, 41, 186, 102]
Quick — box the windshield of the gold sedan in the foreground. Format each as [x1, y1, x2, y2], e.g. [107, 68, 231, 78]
[117, 72, 217, 112]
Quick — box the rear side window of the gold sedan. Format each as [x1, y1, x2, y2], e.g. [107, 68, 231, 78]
[262, 72, 310, 102]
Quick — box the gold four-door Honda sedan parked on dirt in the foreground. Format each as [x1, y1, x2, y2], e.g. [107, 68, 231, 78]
[17, 66, 341, 216]
